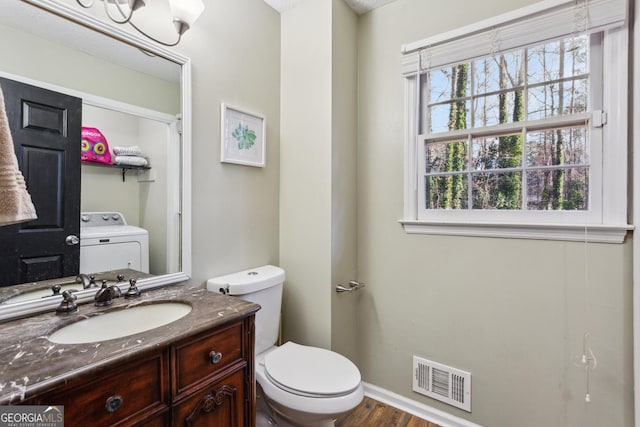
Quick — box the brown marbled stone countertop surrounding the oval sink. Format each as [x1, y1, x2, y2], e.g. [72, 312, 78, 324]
[0, 282, 260, 405]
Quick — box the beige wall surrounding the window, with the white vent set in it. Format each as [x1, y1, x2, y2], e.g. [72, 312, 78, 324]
[358, 0, 633, 427]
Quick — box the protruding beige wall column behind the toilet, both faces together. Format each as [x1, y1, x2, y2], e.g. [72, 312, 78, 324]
[280, 0, 357, 358]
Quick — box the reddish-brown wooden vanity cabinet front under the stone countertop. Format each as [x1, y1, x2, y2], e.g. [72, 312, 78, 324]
[29, 314, 255, 427]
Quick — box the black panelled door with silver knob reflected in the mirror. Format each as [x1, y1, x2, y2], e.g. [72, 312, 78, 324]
[0, 78, 82, 286]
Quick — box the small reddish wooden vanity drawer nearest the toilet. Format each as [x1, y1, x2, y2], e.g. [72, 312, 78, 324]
[173, 322, 245, 395]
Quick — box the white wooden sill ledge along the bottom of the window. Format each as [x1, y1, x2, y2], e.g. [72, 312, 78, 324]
[398, 220, 634, 243]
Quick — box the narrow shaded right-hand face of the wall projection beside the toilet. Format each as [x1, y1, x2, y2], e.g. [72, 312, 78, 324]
[329, 0, 360, 360]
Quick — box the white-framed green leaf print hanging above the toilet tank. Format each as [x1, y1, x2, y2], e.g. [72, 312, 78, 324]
[220, 103, 266, 168]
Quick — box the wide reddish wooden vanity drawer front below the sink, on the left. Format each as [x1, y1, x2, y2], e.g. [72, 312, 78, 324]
[37, 352, 169, 426]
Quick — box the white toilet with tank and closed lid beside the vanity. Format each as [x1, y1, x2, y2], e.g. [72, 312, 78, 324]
[207, 265, 364, 427]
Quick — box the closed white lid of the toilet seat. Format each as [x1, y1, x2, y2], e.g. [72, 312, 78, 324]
[264, 342, 360, 397]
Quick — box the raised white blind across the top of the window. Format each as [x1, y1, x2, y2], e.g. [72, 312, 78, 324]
[401, 0, 628, 74]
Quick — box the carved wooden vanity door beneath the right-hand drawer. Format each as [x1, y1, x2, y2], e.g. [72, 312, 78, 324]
[173, 369, 249, 427]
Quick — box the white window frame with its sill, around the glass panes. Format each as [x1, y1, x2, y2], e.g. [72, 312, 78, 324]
[400, 0, 633, 243]
